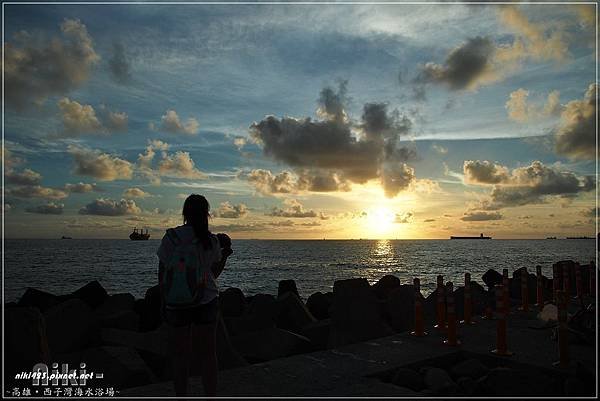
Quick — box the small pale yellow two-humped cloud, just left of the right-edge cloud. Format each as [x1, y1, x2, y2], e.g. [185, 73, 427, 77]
[505, 88, 562, 123]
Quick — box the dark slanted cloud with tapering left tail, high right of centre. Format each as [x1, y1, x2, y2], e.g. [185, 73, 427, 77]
[416, 36, 495, 90]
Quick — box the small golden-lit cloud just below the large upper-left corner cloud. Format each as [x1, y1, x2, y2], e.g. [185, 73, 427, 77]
[58, 97, 128, 136]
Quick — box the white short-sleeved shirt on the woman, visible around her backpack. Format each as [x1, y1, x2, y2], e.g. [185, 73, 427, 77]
[156, 224, 221, 304]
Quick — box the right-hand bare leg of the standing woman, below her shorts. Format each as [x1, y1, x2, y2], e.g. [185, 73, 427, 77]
[192, 323, 218, 397]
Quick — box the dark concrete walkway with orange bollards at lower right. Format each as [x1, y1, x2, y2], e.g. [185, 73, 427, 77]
[119, 306, 596, 397]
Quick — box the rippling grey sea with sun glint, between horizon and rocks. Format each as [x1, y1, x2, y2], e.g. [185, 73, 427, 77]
[4, 239, 596, 301]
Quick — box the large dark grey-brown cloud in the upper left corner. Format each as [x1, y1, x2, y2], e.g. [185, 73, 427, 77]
[4, 19, 100, 109]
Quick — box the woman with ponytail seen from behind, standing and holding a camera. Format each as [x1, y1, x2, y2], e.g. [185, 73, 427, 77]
[156, 194, 233, 396]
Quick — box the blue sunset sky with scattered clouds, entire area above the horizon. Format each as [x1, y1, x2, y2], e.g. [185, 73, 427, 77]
[3, 4, 598, 239]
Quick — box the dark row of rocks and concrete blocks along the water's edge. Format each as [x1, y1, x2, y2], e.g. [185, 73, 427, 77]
[4, 262, 595, 389]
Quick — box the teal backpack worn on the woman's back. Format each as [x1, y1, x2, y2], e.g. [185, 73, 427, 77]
[162, 228, 209, 309]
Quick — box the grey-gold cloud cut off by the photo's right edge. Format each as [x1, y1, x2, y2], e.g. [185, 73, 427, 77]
[555, 83, 598, 160]
